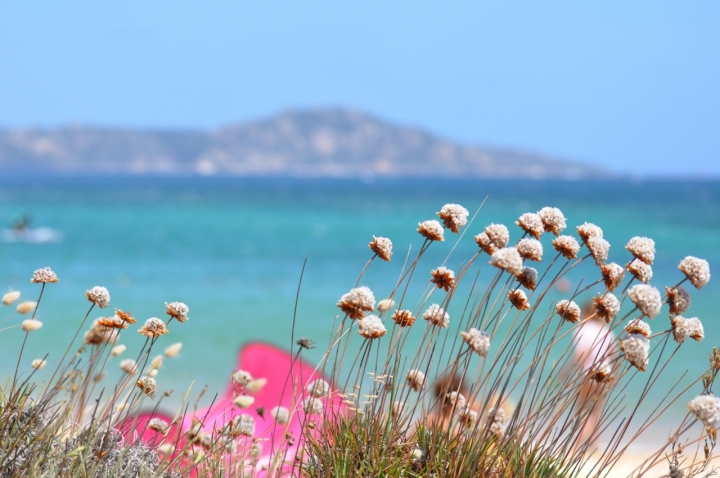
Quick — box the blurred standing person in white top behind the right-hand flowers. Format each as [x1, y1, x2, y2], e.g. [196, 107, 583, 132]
[573, 301, 615, 451]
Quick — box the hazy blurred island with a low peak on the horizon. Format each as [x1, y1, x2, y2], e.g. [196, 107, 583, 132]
[0, 108, 615, 179]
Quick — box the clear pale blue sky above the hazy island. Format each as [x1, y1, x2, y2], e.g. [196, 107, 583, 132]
[0, 0, 720, 177]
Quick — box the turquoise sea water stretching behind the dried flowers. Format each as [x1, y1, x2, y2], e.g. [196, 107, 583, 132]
[0, 178, 720, 426]
